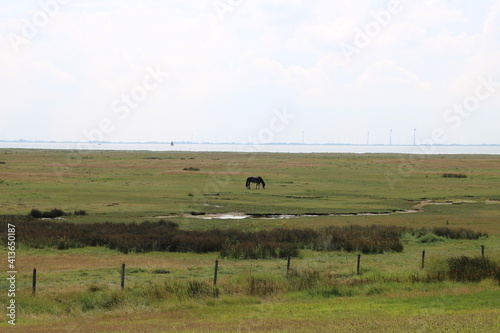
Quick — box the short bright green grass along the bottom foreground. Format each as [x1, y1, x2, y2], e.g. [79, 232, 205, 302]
[4, 282, 500, 332]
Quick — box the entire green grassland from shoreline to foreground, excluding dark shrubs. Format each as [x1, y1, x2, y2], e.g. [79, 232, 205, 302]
[0, 150, 500, 332]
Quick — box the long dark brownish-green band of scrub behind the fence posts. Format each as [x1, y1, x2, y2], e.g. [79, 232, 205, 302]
[3, 214, 487, 259]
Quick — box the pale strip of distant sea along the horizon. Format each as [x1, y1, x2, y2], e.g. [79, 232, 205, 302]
[0, 141, 500, 155]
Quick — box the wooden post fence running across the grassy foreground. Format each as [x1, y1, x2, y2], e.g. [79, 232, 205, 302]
[3, 245, 500, 295]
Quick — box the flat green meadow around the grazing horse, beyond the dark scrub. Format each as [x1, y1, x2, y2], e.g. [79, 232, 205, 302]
[0, 150, 500, 221]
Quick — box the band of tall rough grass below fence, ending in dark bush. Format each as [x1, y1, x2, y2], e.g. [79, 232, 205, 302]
[11, 256, 500, 315]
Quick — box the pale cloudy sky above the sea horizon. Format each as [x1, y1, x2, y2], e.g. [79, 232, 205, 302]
[0, 0, 500, 144]
